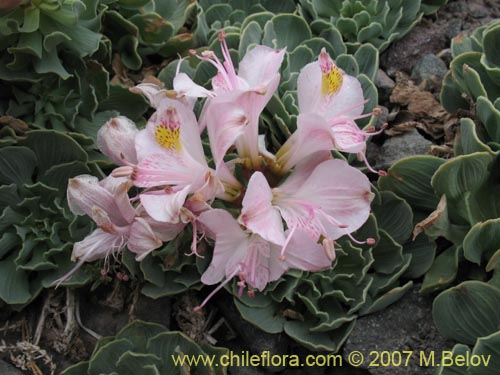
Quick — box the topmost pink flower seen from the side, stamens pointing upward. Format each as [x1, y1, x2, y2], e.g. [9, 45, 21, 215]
[184, 32, 285, 167]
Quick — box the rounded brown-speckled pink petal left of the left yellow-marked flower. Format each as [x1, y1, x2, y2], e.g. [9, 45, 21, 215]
[96, 116, 139, 165]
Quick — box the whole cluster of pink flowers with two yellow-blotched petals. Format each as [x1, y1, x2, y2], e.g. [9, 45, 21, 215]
[62, 33, 382, 309]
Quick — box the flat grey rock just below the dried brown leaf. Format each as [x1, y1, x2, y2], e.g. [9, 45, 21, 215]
[367, 129, 432, 169]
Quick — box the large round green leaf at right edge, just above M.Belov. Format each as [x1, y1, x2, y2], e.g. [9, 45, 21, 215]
[432, 281, 500, 344]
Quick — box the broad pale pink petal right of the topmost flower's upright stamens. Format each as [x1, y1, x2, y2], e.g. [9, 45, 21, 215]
[238, 45, 285, 87]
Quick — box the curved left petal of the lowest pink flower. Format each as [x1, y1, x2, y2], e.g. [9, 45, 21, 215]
[198, 209, 248, 285]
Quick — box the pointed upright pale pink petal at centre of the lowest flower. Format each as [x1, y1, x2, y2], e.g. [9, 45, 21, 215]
[240, 172, 285, 245]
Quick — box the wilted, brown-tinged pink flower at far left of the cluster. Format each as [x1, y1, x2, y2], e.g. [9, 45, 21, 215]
[56, 175, 176, 283]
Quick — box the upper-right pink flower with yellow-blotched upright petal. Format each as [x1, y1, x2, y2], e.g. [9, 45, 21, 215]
[290, 49, 386, 175]
